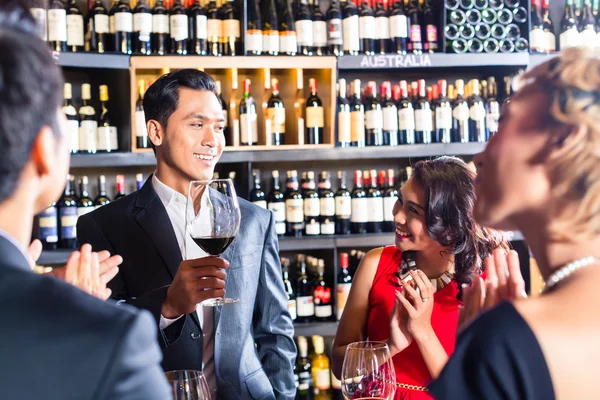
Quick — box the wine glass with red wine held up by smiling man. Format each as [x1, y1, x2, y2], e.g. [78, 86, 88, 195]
[185, 179, 240, 307]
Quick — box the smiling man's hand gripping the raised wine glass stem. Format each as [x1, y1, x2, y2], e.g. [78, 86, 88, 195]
[161, 257, 229, 319]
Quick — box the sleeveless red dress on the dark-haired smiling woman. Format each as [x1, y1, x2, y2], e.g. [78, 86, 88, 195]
[367, 246, 459, 400]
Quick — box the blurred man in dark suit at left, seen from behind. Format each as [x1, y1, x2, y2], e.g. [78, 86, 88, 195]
[0, 0, 170, 400]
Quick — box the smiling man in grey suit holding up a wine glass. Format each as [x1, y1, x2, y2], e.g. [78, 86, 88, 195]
[77, 69, 296, 399]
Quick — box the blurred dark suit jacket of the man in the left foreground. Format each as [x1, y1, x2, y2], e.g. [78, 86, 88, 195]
[0, 236, 171, 400]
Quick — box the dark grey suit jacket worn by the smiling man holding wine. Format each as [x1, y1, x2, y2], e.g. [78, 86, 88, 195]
[77, 176, 296, 399]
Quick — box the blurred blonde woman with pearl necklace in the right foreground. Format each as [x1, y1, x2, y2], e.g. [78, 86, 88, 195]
[430, 48, 600, 400]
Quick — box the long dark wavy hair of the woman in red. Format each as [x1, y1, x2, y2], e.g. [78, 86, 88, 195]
[403, 156, 508, 287]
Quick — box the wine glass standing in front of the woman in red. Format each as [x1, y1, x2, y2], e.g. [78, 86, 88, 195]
[342, 342, 396, 400]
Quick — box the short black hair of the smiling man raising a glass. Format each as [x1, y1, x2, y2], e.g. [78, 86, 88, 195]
[144, 68, 217, 148]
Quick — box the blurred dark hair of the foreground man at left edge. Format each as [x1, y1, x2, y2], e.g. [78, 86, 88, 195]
[0, 15, 63, 202]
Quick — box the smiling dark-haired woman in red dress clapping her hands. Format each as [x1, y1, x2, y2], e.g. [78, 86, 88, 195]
[333, 157, 506, 400]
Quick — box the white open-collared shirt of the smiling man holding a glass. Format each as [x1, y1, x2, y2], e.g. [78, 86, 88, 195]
[152, 172, 217, 398]
